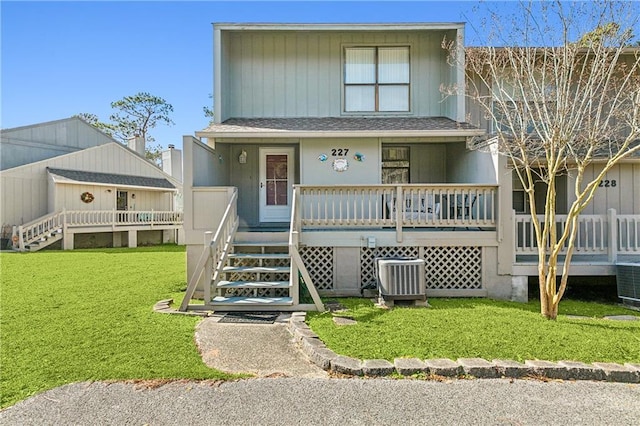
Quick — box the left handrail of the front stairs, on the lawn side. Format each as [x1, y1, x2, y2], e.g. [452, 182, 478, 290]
[179, 187, 238, 312]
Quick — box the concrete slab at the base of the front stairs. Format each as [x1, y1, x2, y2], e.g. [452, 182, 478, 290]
[195, 318, 328, 377]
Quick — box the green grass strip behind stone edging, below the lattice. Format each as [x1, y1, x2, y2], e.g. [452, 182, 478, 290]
[307, 299, 640, 363]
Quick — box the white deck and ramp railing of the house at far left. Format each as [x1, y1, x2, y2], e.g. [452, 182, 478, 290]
[13, 210, 183, 251]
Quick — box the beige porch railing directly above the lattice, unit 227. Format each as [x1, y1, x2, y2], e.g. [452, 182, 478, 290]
[295, 184, 498, 241]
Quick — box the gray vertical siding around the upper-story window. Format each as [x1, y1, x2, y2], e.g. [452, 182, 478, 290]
[221, 31, 456, 121]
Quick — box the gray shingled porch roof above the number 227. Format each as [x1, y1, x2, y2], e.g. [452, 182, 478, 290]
[197, 117, 482, 135]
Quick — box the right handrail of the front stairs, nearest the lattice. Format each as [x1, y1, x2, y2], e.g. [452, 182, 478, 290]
[289, 185, 324, 312]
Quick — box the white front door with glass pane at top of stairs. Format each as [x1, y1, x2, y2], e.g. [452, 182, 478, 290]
[259, 147, 295, 222]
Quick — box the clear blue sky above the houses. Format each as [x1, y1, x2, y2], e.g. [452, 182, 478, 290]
[0, 1, 490, 151]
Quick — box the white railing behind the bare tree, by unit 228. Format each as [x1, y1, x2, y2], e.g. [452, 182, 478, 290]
[514, 209, 640, 262]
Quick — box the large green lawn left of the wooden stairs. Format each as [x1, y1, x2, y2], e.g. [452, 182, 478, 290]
[0, 246, 231, 407]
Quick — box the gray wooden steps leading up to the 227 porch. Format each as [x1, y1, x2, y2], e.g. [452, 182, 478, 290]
[211, 233, 294, 311]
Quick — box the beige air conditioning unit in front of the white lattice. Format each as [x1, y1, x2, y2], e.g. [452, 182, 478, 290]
[378, 259, 427, 300]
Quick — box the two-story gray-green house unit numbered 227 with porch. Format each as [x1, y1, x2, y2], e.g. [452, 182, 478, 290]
[182, 23, 640, 310]
